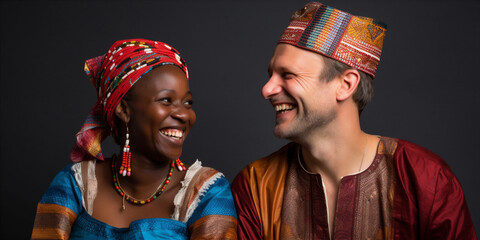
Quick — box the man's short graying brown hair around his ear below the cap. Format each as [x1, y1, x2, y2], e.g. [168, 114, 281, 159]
[321, 56, 373, 114]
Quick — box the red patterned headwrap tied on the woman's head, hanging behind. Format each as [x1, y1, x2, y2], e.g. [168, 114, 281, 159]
[70, 39, 188, 162]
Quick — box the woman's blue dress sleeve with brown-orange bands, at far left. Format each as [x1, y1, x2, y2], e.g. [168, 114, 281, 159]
[32, 164, 82, 239]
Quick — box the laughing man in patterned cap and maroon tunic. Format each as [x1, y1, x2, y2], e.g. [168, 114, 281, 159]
[232, 2, 476, 239]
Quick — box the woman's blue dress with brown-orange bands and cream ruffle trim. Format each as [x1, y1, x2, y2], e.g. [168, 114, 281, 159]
[32, 161, 236, 239]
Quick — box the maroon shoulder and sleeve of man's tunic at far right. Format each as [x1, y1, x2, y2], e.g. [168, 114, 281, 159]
[394, 140, 477, 240]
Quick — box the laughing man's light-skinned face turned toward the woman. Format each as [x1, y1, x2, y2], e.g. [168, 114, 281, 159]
[262, 44, 338, 140]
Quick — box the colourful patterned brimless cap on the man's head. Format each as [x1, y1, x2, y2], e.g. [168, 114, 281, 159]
[279, 2, 387, 77]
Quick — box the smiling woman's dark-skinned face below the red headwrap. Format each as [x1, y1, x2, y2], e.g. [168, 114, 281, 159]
[127, 65, 196, 161]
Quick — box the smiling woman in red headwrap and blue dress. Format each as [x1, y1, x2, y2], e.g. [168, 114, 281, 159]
[32, 39, 236, 239]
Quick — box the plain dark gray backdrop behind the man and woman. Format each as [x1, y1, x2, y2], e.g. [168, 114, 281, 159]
[0, 0, 480, 239]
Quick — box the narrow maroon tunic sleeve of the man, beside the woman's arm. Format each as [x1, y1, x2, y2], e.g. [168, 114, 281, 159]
[232, 171, 263, 240]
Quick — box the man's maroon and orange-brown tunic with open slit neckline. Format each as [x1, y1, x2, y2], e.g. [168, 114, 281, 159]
[232, 137, 477, 239]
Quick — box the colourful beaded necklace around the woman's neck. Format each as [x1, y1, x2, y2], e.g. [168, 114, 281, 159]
[112, 155, 176, 210]
